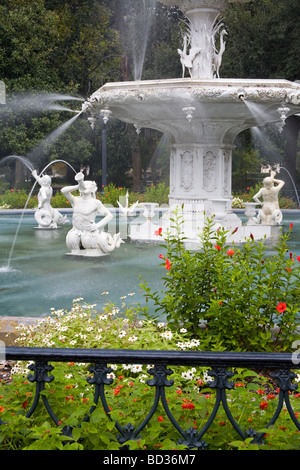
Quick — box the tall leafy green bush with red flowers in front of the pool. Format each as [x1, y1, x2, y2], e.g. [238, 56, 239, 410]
[141, 213, 300, 351]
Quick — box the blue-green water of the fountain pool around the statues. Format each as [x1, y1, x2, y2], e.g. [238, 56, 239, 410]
[0, 210, 300, 317]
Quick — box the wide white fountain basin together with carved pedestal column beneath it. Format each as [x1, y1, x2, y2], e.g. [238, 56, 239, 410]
[83, 78, 300, 215]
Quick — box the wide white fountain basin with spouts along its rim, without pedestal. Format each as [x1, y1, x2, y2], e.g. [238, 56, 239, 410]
[82, 78, 300, 144]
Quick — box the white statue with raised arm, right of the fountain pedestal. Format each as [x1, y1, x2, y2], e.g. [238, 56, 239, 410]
[253, 170, 284, 225]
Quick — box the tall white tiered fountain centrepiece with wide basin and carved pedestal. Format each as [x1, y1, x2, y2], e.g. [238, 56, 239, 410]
[82, 0, 300, 241]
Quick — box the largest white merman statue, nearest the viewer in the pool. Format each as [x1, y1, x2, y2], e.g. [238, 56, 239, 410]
[61, 172, 124, 256]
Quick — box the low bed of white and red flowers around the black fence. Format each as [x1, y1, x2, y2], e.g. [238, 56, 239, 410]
[0, 298, 300, 450]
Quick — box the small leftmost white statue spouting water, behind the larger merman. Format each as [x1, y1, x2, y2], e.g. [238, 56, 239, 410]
[32, 170, 68, 229]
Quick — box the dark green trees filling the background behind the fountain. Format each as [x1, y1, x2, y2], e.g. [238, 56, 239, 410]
[0, 0, 300, 191]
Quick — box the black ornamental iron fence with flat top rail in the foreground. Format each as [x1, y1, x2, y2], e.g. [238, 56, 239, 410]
[0, 347, 300, 450]
